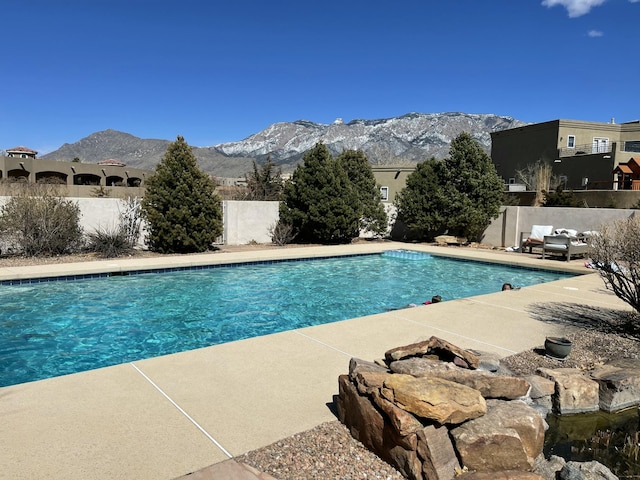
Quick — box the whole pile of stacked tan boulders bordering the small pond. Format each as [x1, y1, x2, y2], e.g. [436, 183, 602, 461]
[337, 337, 640, 480]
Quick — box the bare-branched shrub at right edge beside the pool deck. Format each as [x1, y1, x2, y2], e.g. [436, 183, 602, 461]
[591, 215, 640, 313]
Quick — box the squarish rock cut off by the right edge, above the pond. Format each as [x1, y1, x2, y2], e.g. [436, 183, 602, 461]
[591, 358, 640, 412]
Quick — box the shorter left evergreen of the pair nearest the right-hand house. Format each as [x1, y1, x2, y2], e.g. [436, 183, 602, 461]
[395, 157, 445, 240]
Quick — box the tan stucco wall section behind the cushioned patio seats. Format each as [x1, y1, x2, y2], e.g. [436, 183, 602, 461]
[482, 207, 637, 247]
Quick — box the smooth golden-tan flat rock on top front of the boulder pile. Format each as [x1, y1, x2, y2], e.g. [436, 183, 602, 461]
[382, 374, 487, 424]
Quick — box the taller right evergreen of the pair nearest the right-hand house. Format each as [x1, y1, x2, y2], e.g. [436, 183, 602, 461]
[439, 132, 504, 240]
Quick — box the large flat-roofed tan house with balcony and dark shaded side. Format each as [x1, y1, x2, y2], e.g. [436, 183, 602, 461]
[491, 120, 640, 190]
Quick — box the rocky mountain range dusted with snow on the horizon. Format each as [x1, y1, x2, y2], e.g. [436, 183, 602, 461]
[40, 113, 526, 178]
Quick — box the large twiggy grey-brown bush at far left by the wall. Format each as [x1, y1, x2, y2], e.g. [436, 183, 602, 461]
[0, 184, 82, 256]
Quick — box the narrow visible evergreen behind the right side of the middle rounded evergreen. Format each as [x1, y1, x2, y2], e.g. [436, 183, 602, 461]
[336, 150, 387, 235]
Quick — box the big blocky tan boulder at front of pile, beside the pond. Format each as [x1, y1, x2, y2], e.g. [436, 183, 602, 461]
[451, 400, 544, 472]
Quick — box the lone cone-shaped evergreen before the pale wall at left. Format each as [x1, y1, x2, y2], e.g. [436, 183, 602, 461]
[143, 136, 222, 253]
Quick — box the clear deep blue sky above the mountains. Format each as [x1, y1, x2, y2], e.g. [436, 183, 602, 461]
[0, 0, 640, 154]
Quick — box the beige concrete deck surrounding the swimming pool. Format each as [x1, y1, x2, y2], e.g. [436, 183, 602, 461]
[0, 242, 630, 480]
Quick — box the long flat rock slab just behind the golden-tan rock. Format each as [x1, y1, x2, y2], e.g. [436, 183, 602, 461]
[389, 357, 530, 400]
